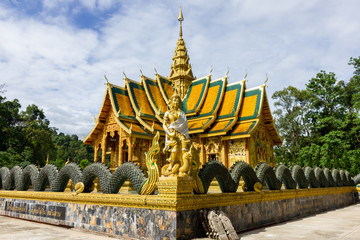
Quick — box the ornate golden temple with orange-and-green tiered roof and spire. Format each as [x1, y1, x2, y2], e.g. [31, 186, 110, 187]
[84, 6, 282, 169]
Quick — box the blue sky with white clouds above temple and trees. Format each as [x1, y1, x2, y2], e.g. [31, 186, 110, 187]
[0, 0, 360, 137]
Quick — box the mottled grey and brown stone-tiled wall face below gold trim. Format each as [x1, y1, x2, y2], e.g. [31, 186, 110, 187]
[0, 192, 354, 239]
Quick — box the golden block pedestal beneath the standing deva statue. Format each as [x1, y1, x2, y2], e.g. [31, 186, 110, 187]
[157, 176, 194, 198]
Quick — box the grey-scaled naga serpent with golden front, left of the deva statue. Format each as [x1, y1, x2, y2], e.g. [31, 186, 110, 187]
[0, 133, 160, 194]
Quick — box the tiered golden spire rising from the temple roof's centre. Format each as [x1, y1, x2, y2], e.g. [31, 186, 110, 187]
[169, 6, 195, 98]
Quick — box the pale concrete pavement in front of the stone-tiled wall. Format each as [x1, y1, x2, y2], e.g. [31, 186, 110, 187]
[0, 204, 360, 240]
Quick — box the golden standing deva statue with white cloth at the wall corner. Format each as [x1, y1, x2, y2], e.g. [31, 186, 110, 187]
[161, 93, 191, 176]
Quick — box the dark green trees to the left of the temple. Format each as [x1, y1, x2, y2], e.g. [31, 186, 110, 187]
[0, 84, 93, 168]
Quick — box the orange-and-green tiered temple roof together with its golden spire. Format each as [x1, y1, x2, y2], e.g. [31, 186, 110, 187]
[84, 9, 282, 144]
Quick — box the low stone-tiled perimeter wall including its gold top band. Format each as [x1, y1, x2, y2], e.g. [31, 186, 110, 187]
[0, 187, 357, 239]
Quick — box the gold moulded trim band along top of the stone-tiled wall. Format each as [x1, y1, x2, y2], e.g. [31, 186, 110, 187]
[0, 187, 356, 211]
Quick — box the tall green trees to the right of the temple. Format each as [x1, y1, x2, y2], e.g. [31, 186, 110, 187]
[272, 57, 360, 175]
